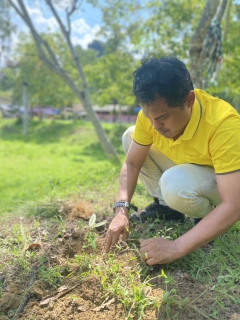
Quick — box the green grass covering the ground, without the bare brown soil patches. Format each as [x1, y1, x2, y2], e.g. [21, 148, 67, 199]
[0, 115, 240, 320]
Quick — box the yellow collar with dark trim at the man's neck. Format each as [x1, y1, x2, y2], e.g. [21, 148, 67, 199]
[182, 97, 202, 140]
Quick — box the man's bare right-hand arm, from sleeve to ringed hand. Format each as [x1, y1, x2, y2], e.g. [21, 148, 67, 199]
[140, 172, 240, 265]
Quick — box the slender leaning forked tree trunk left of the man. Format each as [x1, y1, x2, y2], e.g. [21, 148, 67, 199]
[9, 0, 120, 164]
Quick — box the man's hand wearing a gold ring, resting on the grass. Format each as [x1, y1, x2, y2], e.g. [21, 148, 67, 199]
[140, 238, 180, 266]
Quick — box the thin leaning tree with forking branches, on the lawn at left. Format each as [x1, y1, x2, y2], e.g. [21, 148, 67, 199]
[9, 0, 120, 163]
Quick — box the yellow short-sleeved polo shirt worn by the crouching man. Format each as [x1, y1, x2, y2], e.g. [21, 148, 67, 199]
[133, 89, 240, 174]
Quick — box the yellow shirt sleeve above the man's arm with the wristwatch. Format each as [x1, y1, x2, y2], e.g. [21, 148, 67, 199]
[133, 110, 153, 146]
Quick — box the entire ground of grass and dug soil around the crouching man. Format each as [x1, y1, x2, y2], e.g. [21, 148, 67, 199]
[0, 119, 240, 320]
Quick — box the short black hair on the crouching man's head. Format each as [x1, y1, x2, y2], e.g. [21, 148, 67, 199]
[133, 57, 193, 108]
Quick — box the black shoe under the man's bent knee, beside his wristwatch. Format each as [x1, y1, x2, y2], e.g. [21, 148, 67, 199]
[129, 198, 185, 223]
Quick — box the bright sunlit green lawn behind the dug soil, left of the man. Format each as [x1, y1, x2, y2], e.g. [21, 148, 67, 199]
[0, 119, 130, 214]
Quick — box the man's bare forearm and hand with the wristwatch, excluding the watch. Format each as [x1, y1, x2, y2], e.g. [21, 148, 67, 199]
[103, 141, 151, 253]
